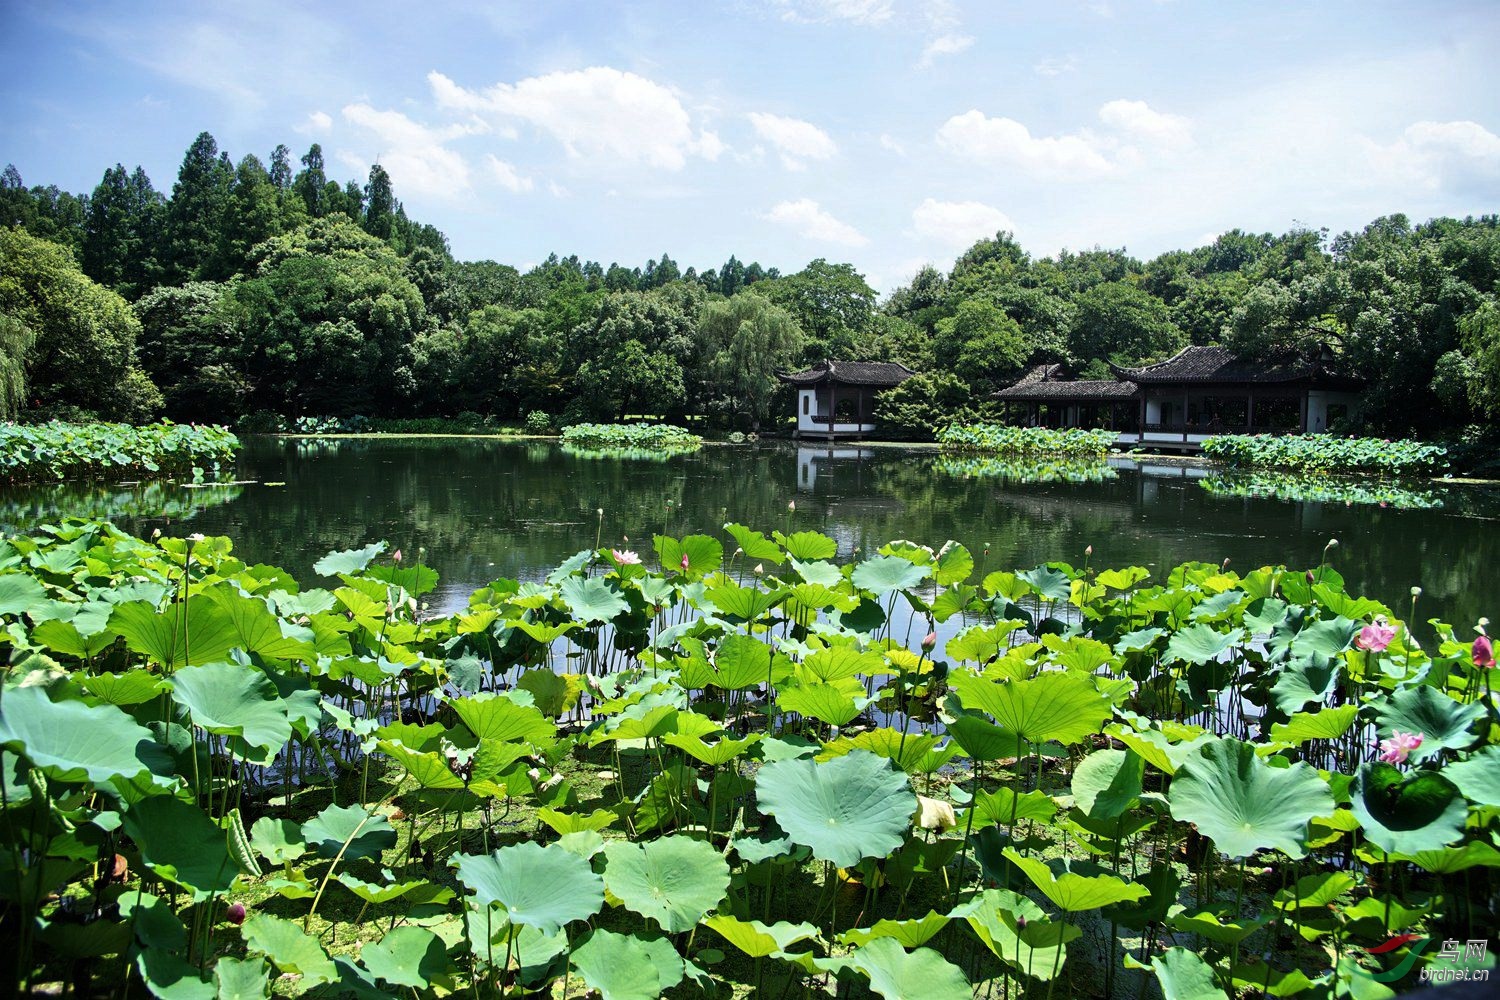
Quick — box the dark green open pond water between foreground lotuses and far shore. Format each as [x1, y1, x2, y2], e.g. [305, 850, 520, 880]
[0, 438, 1500, 636]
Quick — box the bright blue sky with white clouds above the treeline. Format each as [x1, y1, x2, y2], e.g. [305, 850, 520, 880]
[0, 0, 1500, 291]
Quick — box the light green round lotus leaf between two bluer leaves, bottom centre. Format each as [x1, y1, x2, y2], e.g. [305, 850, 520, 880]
[605, 837, 729, 934]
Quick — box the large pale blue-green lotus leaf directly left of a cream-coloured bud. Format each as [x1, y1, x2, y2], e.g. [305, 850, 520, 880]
[756, 750, 917, 868]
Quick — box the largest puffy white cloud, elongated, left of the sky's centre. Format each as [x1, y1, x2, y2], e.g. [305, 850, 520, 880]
[428, 66, 725, 169]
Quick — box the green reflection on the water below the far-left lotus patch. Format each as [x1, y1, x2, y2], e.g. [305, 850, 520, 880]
[0, 483, 245, 534]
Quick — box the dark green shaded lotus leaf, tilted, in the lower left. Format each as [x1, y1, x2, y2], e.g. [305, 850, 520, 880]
[125, 796, 240, 900]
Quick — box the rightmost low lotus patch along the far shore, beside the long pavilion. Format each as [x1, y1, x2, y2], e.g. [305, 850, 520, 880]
[1203, 433, 1448, 477]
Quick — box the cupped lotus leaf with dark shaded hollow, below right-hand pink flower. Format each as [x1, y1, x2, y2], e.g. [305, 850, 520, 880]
[1350, 763, 1469, 855]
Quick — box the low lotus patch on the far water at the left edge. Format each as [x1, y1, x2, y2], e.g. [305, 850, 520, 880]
[0, 420, 240, 483]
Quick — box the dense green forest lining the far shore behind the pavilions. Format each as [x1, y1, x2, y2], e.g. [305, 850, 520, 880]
[0, 132, 1500, 439]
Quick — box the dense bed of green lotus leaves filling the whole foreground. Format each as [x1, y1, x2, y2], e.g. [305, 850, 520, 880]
[0, 522, 1500, 1000]
